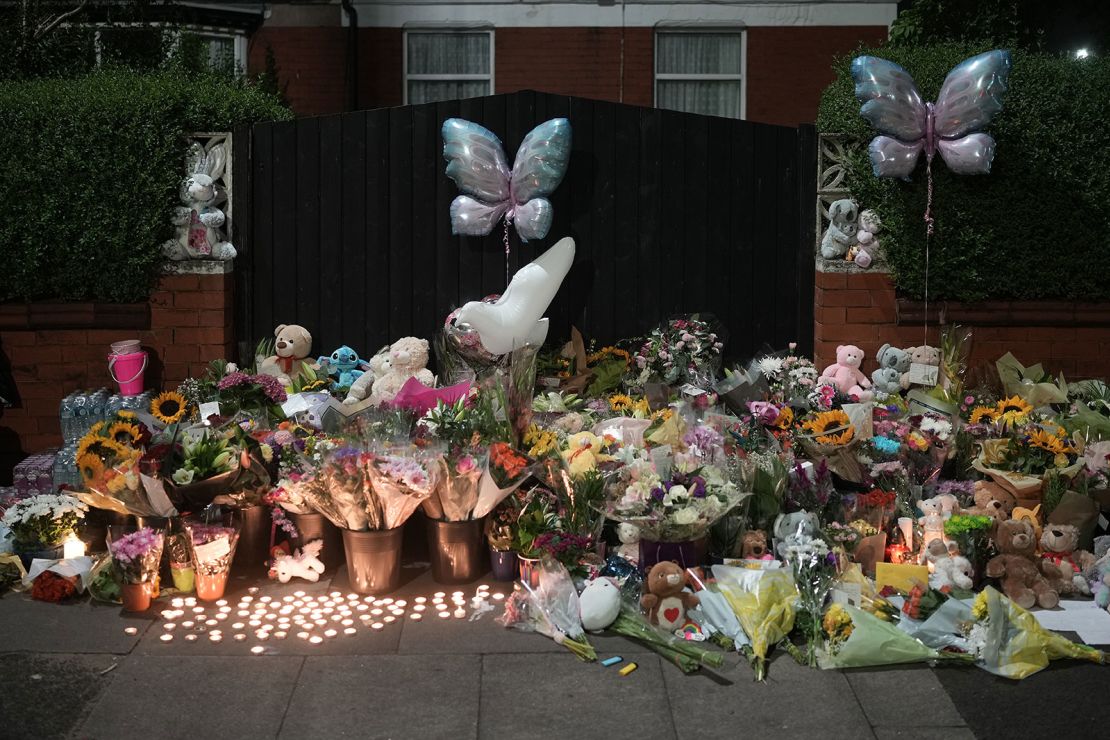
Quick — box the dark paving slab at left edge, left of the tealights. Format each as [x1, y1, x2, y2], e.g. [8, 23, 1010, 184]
[0, 594, 153, 655]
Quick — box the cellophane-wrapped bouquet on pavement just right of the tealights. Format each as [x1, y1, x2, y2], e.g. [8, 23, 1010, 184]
[497, 556, 597, 661]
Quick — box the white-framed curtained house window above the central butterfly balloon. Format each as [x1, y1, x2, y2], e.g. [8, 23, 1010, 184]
[404, 30, 493, 105]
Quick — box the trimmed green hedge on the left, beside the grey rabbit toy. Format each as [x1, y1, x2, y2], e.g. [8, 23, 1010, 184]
[0, 71, 291, 303]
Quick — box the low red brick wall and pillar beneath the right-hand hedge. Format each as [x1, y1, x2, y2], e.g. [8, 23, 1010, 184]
[814, 271, 1110, 378]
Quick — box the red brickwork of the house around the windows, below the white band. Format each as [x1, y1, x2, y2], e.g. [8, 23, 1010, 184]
[250, 26, 887, 125]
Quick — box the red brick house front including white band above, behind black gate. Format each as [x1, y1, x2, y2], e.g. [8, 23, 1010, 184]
[246, 0, 897, 125]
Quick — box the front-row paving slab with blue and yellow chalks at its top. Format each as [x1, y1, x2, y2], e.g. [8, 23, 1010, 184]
[478, 655, 674, 740]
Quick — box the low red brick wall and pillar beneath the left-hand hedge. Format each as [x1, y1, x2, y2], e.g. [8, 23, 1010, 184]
[0, 274, 235, 454]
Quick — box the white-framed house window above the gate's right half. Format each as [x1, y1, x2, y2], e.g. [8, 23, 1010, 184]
[655, 31, 744, 119]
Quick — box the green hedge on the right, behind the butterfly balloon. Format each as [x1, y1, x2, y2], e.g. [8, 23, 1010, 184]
[817, 44, 1110, 301]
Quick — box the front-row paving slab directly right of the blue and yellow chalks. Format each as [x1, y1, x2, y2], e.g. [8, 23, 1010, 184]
[663, 655, 874, 740]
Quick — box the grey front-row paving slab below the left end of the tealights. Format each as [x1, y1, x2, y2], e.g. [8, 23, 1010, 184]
[77, 656, 304, 740]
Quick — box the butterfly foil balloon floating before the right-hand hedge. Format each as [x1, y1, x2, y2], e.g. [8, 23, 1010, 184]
[851, 49, 1010, 178]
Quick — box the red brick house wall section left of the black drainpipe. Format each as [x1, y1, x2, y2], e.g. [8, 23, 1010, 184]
[246, 27, 348, 115]
